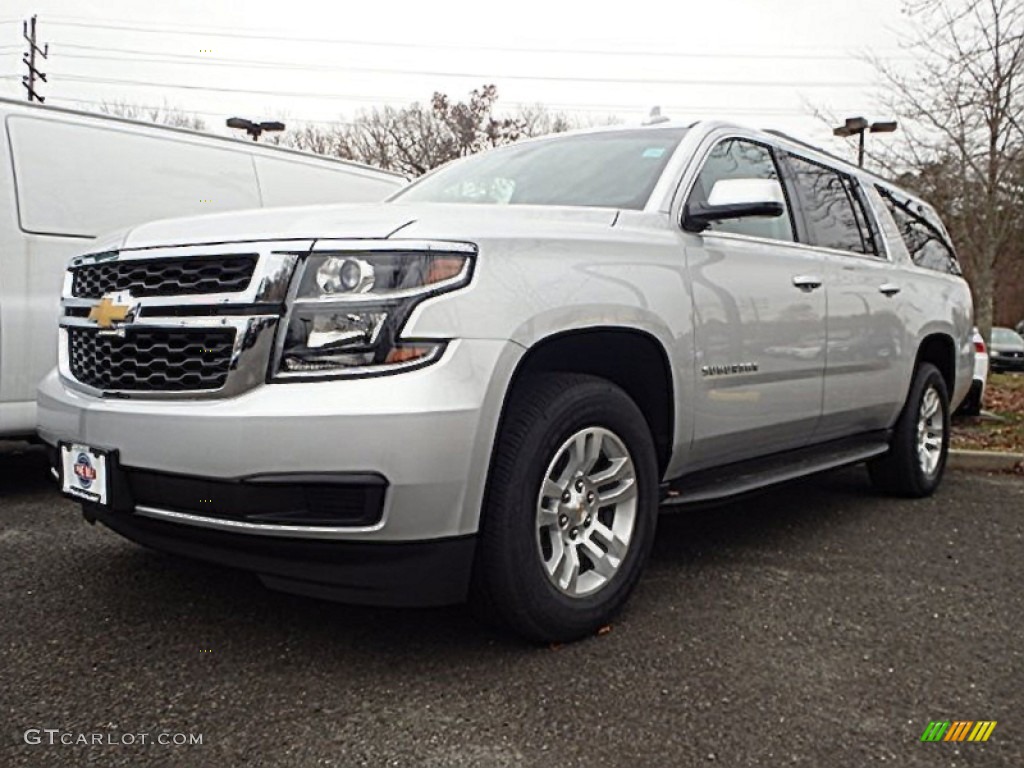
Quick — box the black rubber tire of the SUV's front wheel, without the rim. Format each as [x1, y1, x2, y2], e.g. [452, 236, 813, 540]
[470, 374, 658, 642]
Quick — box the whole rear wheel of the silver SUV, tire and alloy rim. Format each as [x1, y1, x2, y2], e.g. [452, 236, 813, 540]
[867, 362, 949, 498]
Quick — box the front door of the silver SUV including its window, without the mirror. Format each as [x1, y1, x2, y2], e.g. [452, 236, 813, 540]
[680, 137, 825, 470]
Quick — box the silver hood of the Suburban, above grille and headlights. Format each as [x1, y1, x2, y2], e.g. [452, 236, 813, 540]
[116, 203, 617, 250]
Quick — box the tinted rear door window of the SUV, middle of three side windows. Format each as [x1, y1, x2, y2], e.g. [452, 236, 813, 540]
[787, 155, 877, 255]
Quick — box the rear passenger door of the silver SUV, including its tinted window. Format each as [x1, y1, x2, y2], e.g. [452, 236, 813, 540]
[783, 154, 910, 441]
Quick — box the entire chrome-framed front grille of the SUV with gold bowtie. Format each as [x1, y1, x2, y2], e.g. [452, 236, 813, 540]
[57, 241, 303, 400]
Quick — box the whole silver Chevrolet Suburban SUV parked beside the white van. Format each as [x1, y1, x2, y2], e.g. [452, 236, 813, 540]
[39, 123, 973, 641]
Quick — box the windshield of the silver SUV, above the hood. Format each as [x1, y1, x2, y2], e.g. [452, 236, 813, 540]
[392, 128, 686, 210]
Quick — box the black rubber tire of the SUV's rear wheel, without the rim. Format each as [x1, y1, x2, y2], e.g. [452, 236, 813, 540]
[867, 362, 949, 499]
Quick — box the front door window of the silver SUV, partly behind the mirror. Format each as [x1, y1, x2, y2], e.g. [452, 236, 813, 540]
[689, 138, 793, 241]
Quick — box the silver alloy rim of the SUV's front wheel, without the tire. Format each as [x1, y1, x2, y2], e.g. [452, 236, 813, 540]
[537, 427, 637, 597]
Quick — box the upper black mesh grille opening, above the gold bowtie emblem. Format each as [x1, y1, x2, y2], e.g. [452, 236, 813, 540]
[72, 254, 258, 299]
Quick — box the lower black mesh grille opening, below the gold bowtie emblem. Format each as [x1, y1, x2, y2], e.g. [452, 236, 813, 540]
[68, 328, 234, 392]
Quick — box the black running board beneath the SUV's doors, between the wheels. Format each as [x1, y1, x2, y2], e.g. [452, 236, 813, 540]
[662, 431, 891, 508]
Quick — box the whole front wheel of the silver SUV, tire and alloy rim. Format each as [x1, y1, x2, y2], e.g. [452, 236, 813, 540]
[471, 374, 657, 642]
